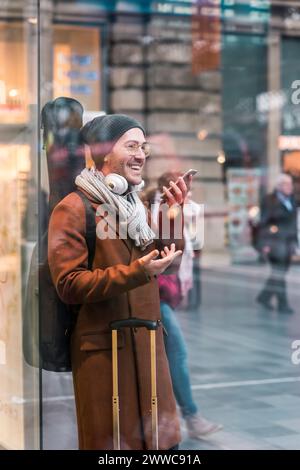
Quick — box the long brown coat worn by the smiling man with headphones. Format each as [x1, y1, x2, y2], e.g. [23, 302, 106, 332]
[48, 193, 182, 450]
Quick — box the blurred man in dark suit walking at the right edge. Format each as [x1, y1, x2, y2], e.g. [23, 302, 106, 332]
[257, 173, 298, 313]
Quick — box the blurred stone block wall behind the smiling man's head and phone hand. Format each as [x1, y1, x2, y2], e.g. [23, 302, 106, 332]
[109, 13, 226, 249]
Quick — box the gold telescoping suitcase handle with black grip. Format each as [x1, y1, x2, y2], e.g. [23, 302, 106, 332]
[110, 317, 159, 450]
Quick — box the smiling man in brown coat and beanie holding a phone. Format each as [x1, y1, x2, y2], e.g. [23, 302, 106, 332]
[48, 115, 191, 450]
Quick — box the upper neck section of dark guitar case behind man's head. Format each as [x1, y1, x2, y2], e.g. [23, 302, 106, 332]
[42, 97, 85, 212]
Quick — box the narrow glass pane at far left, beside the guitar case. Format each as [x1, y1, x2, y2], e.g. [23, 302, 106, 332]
[0, 2, 40, 449]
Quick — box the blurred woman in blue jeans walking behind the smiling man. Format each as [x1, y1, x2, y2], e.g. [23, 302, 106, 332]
[142, 171, 223, 439]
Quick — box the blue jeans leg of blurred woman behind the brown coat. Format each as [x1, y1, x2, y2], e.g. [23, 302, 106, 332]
[160, 302, 198, 417]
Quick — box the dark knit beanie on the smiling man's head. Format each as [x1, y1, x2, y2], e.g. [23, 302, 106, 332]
[81, 114, 145, 148]
